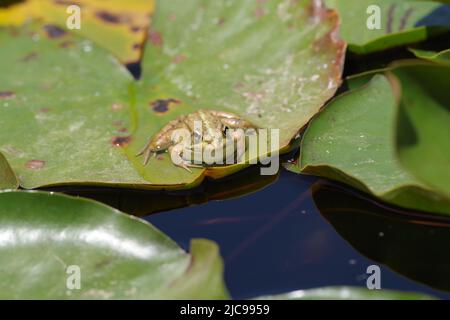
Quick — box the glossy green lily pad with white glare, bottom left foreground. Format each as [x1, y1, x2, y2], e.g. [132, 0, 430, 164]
[0, 191, 228, 299]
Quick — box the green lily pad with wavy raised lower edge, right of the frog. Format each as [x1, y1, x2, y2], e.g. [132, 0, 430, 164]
[288, 70, 450, 214]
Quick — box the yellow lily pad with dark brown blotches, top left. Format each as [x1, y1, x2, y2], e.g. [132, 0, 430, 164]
[0, 0, 154, 64]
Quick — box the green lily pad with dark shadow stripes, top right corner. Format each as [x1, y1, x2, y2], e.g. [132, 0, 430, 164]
[325, 0, 442, 54]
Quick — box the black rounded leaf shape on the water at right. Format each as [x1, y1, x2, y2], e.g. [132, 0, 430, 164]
[312, 182, 450, 291]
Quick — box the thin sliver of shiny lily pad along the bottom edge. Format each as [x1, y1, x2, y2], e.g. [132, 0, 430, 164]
[256, 287, 435, 300]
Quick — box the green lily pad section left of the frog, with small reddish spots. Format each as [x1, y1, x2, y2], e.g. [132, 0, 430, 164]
[0, 27, 151, 188]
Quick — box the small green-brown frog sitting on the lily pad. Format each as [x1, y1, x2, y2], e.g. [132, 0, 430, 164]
[136, 109, 257, 172]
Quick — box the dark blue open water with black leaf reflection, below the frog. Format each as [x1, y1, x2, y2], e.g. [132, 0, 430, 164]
[145, 171, 450, 298]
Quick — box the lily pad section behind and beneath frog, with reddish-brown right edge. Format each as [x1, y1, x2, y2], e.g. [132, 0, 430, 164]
[128, 0, 345, 184]
